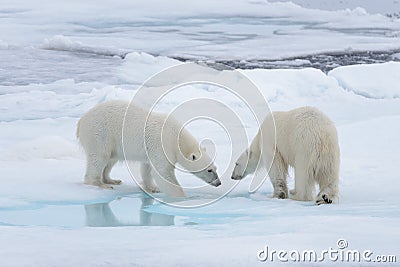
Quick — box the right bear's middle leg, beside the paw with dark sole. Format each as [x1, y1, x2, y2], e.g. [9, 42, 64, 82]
[291, 157, 315, 201]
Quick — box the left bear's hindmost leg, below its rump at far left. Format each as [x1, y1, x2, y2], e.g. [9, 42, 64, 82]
[84, 154, 112, 189]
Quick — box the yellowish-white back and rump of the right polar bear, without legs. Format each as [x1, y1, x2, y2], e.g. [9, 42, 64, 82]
[262, 107, 339, 166]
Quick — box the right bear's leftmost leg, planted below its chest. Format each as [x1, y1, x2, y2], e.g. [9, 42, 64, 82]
[268, 155, 288, 198]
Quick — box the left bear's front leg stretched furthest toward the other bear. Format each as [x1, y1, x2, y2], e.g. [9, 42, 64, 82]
[151, 162, 185, 197]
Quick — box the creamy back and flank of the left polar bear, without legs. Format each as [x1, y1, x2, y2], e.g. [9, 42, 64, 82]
[77, 100, 179, 161]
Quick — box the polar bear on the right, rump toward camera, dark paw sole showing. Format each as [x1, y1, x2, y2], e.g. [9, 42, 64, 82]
[232, 107, 340, 205]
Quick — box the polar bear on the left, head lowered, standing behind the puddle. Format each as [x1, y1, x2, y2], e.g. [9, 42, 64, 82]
[76, 100, 221, 197]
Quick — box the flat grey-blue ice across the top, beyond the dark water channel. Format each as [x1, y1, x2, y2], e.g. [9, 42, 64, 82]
[0, 0, 400, 59]
